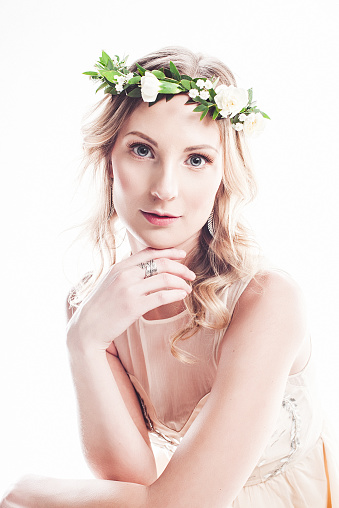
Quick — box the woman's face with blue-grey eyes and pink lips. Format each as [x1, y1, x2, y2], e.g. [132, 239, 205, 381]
[112, 95, 223, 253]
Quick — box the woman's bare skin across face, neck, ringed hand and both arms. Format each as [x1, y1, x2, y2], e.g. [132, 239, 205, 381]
[0, 96, 310, 508]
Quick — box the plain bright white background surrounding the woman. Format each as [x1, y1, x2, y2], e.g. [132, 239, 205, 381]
[0, 0, 339, 493]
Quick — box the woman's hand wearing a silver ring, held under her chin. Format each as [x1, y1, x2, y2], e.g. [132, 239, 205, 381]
[67, 248, 195, 351]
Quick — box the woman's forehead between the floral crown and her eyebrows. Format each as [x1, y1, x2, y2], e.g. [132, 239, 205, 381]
[118, 94, 221, 148]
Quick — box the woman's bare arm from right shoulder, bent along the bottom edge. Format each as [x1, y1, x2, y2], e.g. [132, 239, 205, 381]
[0, 274, 306, 508]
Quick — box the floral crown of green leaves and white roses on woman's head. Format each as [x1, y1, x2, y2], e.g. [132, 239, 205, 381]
[83, 51, 270, 134]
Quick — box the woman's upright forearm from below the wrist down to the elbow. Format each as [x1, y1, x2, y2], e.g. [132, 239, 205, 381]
[69, 347, 155, 483]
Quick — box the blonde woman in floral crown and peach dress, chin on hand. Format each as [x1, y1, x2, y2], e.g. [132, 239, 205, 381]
[1, 48, 339, 508]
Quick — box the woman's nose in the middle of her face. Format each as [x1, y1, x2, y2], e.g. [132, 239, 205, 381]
[151, 162, 178, 201]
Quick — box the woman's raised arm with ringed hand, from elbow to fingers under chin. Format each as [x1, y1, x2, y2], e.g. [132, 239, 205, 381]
[67, 249, 195, 485]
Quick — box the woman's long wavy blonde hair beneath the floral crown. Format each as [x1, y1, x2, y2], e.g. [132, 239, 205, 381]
[69, 46, 263, 363]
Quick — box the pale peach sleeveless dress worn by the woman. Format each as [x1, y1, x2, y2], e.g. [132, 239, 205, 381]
[114, 278, 339, 508]
